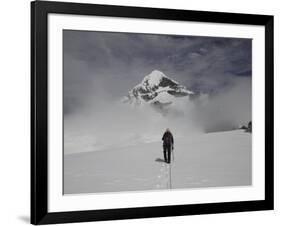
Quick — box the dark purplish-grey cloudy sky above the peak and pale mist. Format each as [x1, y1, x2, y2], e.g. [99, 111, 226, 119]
[63, 30, 252, 113]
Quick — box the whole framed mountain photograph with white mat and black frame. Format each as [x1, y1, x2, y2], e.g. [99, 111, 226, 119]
[31, 1, 273, 224]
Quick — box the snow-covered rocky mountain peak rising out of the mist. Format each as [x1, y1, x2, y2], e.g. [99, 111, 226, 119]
[122, 70, 194, 113]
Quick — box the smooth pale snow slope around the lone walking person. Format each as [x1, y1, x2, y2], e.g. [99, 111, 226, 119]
[64, 130, 252, 194]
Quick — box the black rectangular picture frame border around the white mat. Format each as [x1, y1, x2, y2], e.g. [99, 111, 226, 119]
[31, 1, 274, 224]
